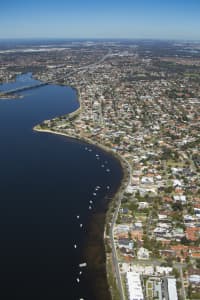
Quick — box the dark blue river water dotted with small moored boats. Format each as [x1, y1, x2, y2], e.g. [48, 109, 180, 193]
[0, 74, 122, 300]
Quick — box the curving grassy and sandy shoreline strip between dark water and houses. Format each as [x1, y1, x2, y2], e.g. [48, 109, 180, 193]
[33, 86, 131, 300]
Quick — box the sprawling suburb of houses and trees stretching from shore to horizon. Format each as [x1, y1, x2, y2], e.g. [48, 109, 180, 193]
[0, 41, 200, 300]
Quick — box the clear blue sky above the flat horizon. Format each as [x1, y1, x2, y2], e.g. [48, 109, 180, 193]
[0, 0, 200, 40]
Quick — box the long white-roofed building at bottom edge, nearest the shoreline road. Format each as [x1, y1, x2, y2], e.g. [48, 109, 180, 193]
[126, 272, 144, 300]
